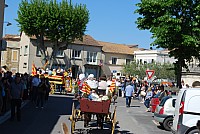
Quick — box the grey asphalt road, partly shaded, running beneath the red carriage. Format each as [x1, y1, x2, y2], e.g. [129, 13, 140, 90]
[0, 95, 171, 134]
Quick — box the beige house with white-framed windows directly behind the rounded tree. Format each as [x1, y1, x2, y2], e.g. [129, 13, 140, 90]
[19, 32, 102, 78]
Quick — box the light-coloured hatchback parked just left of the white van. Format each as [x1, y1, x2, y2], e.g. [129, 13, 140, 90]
[154, 96, 176, 131]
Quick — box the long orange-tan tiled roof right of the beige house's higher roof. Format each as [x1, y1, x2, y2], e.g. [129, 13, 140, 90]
[98, 41, 138, 55]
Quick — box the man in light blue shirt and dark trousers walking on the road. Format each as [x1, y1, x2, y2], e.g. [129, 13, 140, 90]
[125, 79, 134, 107]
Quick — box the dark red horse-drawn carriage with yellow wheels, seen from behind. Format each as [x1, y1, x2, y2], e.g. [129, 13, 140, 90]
[69, 98, 117, 134]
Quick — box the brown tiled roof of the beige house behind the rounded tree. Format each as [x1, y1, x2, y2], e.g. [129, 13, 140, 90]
[30, 35, 102, 47]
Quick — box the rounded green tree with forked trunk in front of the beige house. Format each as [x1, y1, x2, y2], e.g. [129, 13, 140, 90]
[16, 0, 89, 66]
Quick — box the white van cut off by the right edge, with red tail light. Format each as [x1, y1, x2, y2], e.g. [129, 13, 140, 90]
[171, 88, 200, 134]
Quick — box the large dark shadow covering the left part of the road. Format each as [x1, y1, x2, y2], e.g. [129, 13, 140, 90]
[0, 95, 72, 134]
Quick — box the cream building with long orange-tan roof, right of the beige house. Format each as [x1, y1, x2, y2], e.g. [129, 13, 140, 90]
[98, 41, 138, 76]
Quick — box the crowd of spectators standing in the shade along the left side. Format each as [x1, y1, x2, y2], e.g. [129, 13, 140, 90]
[0, 71, 50, 121]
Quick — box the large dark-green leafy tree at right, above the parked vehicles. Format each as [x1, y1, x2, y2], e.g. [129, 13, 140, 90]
[135, 0, 200, 87]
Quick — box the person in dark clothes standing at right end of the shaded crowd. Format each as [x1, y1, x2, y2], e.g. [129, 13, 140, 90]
[36, 75, 47, 108]
